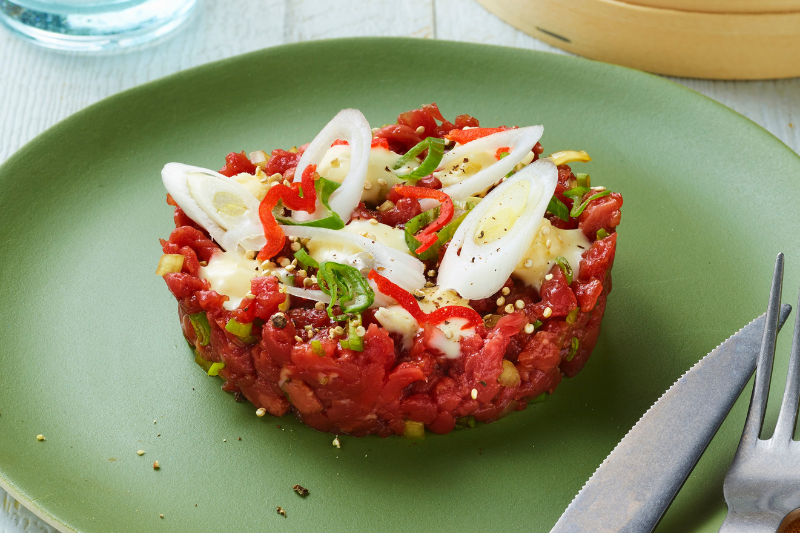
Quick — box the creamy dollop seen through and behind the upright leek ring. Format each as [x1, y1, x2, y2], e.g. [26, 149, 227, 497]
[317, 144, 419, 205]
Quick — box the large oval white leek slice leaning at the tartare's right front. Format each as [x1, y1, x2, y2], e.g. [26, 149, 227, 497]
[437, 160, 558, 300]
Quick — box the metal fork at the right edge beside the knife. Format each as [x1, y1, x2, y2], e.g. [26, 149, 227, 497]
[719, 254, 800, 533]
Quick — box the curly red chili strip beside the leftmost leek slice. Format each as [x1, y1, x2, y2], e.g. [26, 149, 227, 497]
[258, 165, 317, 261]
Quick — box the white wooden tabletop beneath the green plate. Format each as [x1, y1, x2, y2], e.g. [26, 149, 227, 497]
[0, 0, 800, 533]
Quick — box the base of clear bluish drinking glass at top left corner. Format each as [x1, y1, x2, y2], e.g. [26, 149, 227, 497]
[0, 0, 198, 52]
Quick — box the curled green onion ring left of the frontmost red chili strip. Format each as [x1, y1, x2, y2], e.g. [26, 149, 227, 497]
[317, 261, 375, 320]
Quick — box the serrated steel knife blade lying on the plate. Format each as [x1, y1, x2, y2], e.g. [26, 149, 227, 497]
[551, 304, 792, 533]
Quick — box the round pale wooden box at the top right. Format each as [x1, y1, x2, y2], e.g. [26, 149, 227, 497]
[478, 0, 800, 79]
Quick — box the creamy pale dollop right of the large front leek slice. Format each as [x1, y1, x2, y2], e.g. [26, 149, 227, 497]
[511, 220, 591, 291]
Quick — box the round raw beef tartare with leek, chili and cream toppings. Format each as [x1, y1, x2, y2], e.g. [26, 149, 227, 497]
[158, 104, 622, 437]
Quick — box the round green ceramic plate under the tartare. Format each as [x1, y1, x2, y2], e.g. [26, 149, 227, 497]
[0, 39, 800, 533]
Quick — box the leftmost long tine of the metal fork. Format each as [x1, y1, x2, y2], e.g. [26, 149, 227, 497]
[741, 253, 783, 444]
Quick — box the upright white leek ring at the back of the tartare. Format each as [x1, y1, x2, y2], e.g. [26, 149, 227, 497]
[292, 109, 372, 221]
